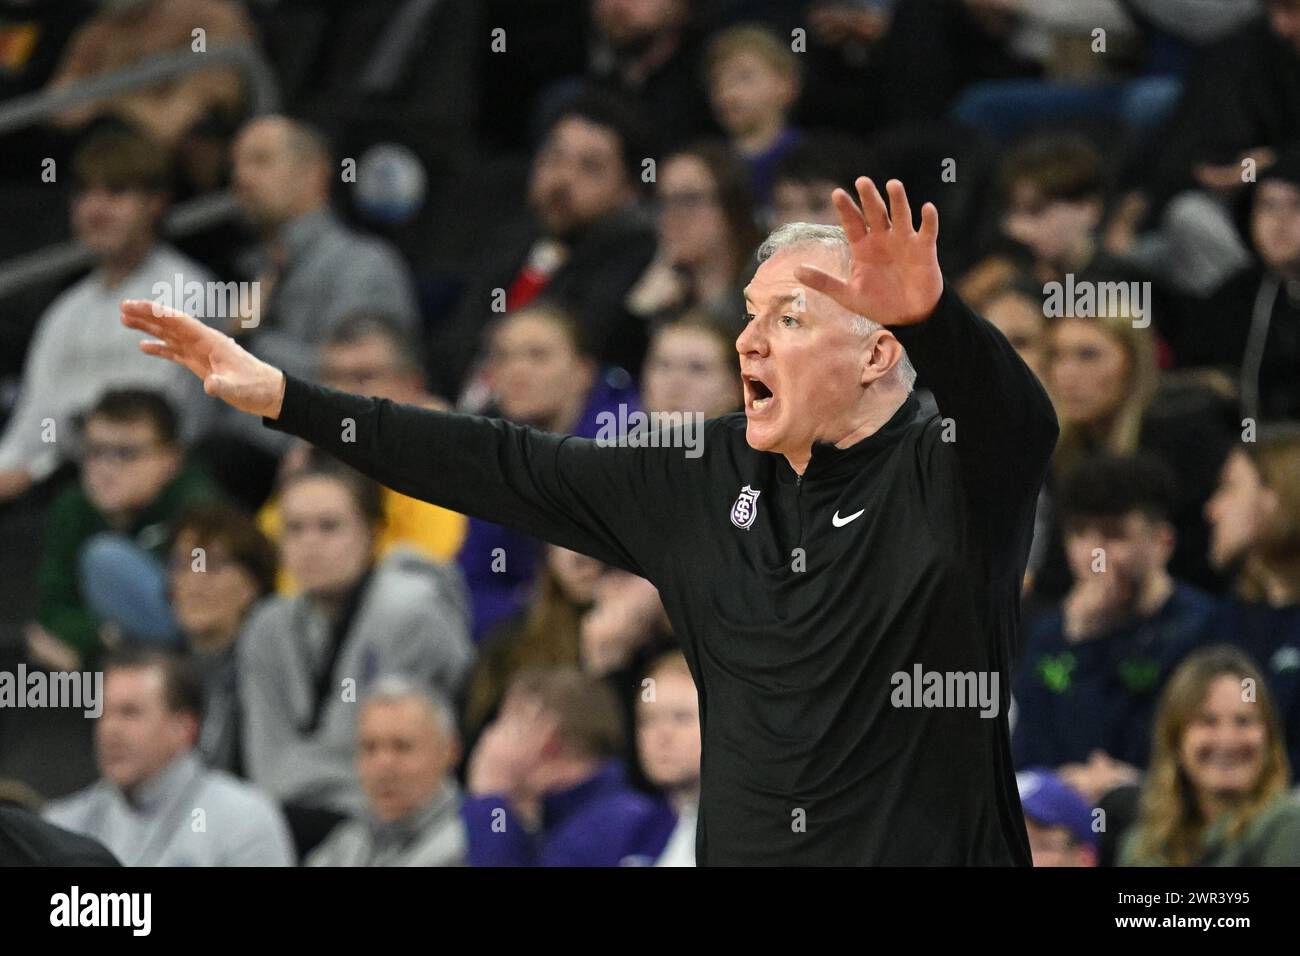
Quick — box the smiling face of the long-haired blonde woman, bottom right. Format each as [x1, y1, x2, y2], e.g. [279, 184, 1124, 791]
[1178, 674, 1269, 799]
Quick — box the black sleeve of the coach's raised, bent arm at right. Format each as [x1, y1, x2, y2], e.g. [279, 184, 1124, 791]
[892, 287, 1060, 561]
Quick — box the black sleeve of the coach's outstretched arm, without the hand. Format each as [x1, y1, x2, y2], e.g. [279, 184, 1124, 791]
[264, 375, 685, 580]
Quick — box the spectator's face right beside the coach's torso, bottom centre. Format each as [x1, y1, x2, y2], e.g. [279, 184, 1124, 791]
[637, 670, 701, 790]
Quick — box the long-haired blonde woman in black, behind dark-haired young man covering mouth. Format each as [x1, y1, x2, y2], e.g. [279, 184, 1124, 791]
[1035, 306, 1232, 598]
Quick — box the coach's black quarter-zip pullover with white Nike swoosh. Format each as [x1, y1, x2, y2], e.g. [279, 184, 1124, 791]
[265, 283, 1057, 865]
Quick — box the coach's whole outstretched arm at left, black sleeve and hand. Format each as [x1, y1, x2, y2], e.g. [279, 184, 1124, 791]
[122, 302, 684, 580]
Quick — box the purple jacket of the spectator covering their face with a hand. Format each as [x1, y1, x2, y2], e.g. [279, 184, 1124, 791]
[462, 760, 677, 866]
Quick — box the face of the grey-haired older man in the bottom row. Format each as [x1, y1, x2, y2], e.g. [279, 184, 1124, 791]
[356, 697, 456, 822]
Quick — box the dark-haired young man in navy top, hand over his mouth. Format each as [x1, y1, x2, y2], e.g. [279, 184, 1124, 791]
[1011, 457, 1216, 805]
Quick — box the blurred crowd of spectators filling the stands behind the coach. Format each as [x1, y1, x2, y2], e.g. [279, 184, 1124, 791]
[0, 0, 1300, 866]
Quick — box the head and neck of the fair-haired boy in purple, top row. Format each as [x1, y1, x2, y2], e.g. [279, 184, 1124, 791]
[707, 23, 803, 209]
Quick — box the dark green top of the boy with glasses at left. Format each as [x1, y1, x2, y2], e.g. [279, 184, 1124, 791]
[36, 463, 217, 666]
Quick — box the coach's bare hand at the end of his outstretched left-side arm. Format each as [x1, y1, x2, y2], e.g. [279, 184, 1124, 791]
[122, 299, 285, 419]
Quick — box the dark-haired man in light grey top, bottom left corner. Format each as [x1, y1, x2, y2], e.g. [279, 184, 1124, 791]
[46, 650, 294, 866]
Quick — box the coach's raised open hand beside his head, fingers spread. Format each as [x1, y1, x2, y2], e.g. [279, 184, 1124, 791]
[794, 176, 944, 325]
